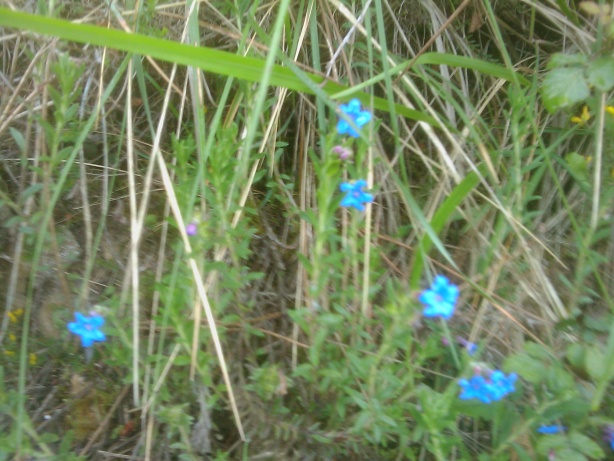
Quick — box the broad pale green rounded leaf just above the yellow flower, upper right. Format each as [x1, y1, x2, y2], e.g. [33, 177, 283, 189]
[541, 67, 590, 113]
